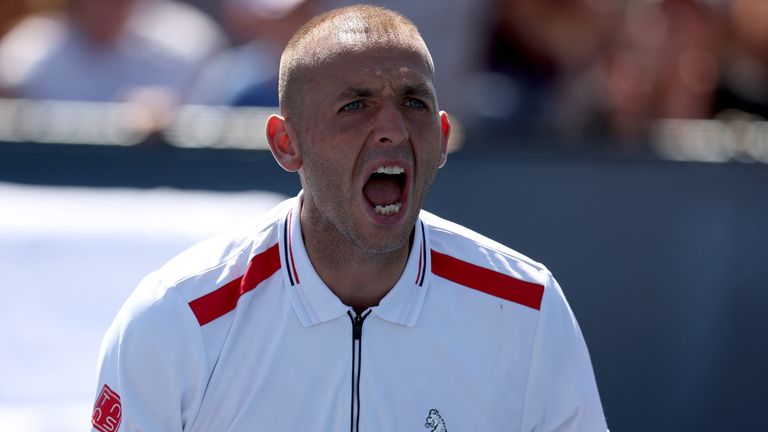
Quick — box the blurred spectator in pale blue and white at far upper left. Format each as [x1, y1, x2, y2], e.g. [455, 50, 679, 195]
[0, 0, 224, 108]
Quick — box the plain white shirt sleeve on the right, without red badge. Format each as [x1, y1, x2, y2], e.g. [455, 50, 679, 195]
[521, 275, 607, 432]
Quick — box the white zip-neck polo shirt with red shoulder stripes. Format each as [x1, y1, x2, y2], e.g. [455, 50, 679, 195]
[92, 197, 606, 432]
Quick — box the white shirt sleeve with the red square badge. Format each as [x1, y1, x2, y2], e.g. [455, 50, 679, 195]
[91, 278, 207, 432]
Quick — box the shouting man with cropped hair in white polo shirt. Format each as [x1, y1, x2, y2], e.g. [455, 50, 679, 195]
[93, 6, 606, 432]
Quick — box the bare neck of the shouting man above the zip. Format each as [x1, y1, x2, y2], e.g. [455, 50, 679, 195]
[301, 202, 412, 313]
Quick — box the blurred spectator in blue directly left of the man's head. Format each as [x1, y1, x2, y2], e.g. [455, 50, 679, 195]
[185, 0, 317, 106]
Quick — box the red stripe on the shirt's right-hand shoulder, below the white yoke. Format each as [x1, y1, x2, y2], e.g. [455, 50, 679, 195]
[431, 250, 544, 310]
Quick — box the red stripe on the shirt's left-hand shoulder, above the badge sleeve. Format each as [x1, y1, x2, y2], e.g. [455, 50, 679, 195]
[189, 244, 280, 326]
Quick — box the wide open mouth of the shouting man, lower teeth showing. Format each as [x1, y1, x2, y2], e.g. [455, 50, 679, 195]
[363, 165, 406, 216]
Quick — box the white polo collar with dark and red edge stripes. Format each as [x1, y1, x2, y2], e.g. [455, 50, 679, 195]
[280, 193, 431, 327]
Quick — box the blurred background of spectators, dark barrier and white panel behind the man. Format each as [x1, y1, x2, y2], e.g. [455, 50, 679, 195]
[0, 0, 768, 432]
